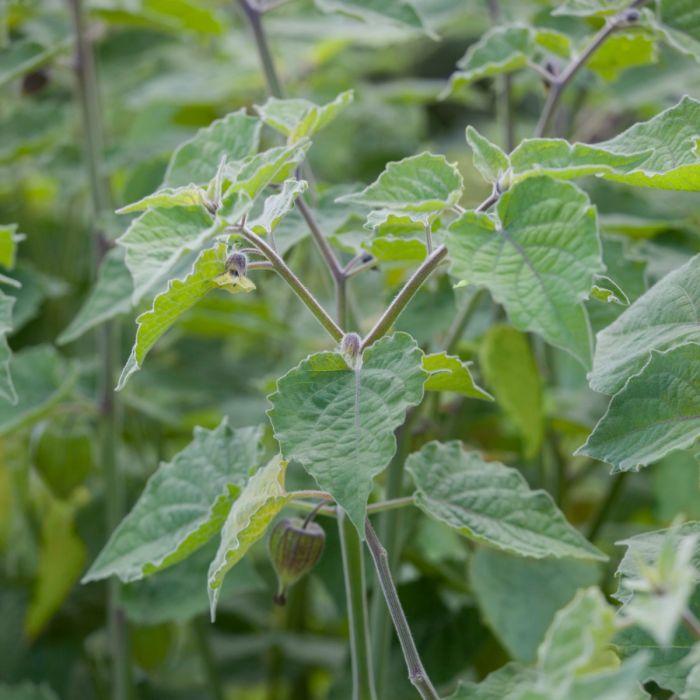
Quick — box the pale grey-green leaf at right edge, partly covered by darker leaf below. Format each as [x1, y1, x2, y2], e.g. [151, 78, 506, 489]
[588, 255, 700, 394]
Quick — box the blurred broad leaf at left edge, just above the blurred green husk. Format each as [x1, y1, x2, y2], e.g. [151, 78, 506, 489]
[0, 345, 78, 435]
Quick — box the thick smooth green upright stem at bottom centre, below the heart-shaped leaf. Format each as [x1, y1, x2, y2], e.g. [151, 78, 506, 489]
[338, 508, 377, 700]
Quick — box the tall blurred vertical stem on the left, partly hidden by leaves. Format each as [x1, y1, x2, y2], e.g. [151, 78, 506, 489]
[69, 0, 133, 700]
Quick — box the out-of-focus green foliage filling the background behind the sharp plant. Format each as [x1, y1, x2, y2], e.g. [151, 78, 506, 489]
[0, 0, 700, 700]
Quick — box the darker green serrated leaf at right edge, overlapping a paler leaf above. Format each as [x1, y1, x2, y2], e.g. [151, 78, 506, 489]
[577, 343, 700, 471]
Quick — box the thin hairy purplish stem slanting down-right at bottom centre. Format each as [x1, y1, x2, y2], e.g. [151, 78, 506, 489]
[365, 518, 440, 700]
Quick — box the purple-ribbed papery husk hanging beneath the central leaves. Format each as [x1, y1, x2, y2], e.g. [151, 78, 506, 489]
[267, 518, 326, 605]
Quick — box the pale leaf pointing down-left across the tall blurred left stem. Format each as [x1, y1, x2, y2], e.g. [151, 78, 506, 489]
[56, 248, 134, 345]
